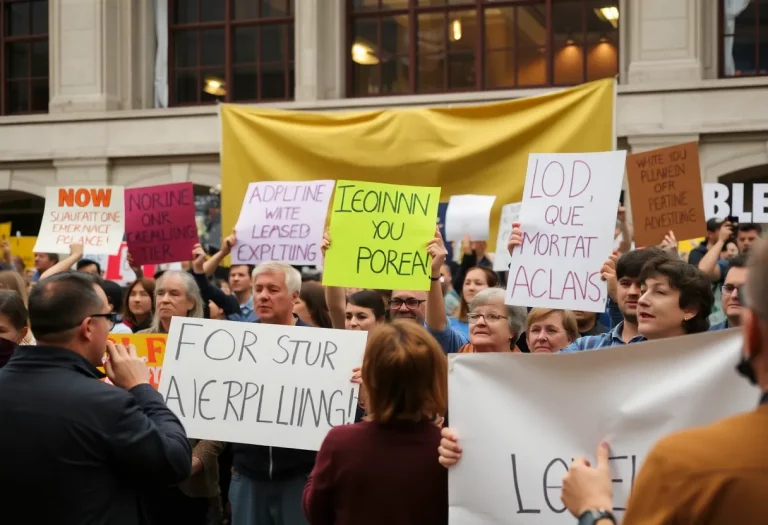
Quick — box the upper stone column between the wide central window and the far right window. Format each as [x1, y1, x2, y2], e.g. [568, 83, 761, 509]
[624, 0, 704, 84]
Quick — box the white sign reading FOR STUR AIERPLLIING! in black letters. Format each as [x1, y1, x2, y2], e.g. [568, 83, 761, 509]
[160, 316, 368, 450]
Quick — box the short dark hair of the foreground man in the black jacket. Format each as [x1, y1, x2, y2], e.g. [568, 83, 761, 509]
[29, 271, 104, 343]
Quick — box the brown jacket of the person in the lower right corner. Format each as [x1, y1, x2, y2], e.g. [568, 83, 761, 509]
[624, 405, 768, 525]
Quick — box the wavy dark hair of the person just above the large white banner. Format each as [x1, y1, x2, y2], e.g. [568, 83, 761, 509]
[638, 256, 715, 334]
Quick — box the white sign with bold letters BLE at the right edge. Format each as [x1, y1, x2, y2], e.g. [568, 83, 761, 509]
[704, 183, 768, 224]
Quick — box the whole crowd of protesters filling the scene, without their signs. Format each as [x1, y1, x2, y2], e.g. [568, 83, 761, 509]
[0, 210, 768, 525]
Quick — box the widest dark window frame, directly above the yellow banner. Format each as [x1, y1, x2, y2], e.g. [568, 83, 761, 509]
[344, 0, 622, 98]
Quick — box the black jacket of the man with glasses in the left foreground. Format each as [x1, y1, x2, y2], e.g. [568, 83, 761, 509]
[0, 346, 192, 525]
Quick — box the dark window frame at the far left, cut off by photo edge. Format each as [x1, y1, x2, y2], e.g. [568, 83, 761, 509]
[0, 0, 51, 117]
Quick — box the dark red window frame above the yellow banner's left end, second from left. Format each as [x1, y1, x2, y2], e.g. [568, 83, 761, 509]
[167, 0, 294, 107]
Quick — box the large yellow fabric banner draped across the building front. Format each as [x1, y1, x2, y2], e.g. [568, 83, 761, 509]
[220, 79, 618, 251]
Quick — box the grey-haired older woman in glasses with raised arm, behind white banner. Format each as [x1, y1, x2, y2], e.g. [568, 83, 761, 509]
[426, 231, 526, 354]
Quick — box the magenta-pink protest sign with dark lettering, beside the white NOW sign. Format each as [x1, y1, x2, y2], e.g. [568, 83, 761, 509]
[125, 182, 198, 265]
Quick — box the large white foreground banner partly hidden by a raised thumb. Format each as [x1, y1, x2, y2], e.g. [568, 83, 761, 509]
[448, 330, 759, 525]
